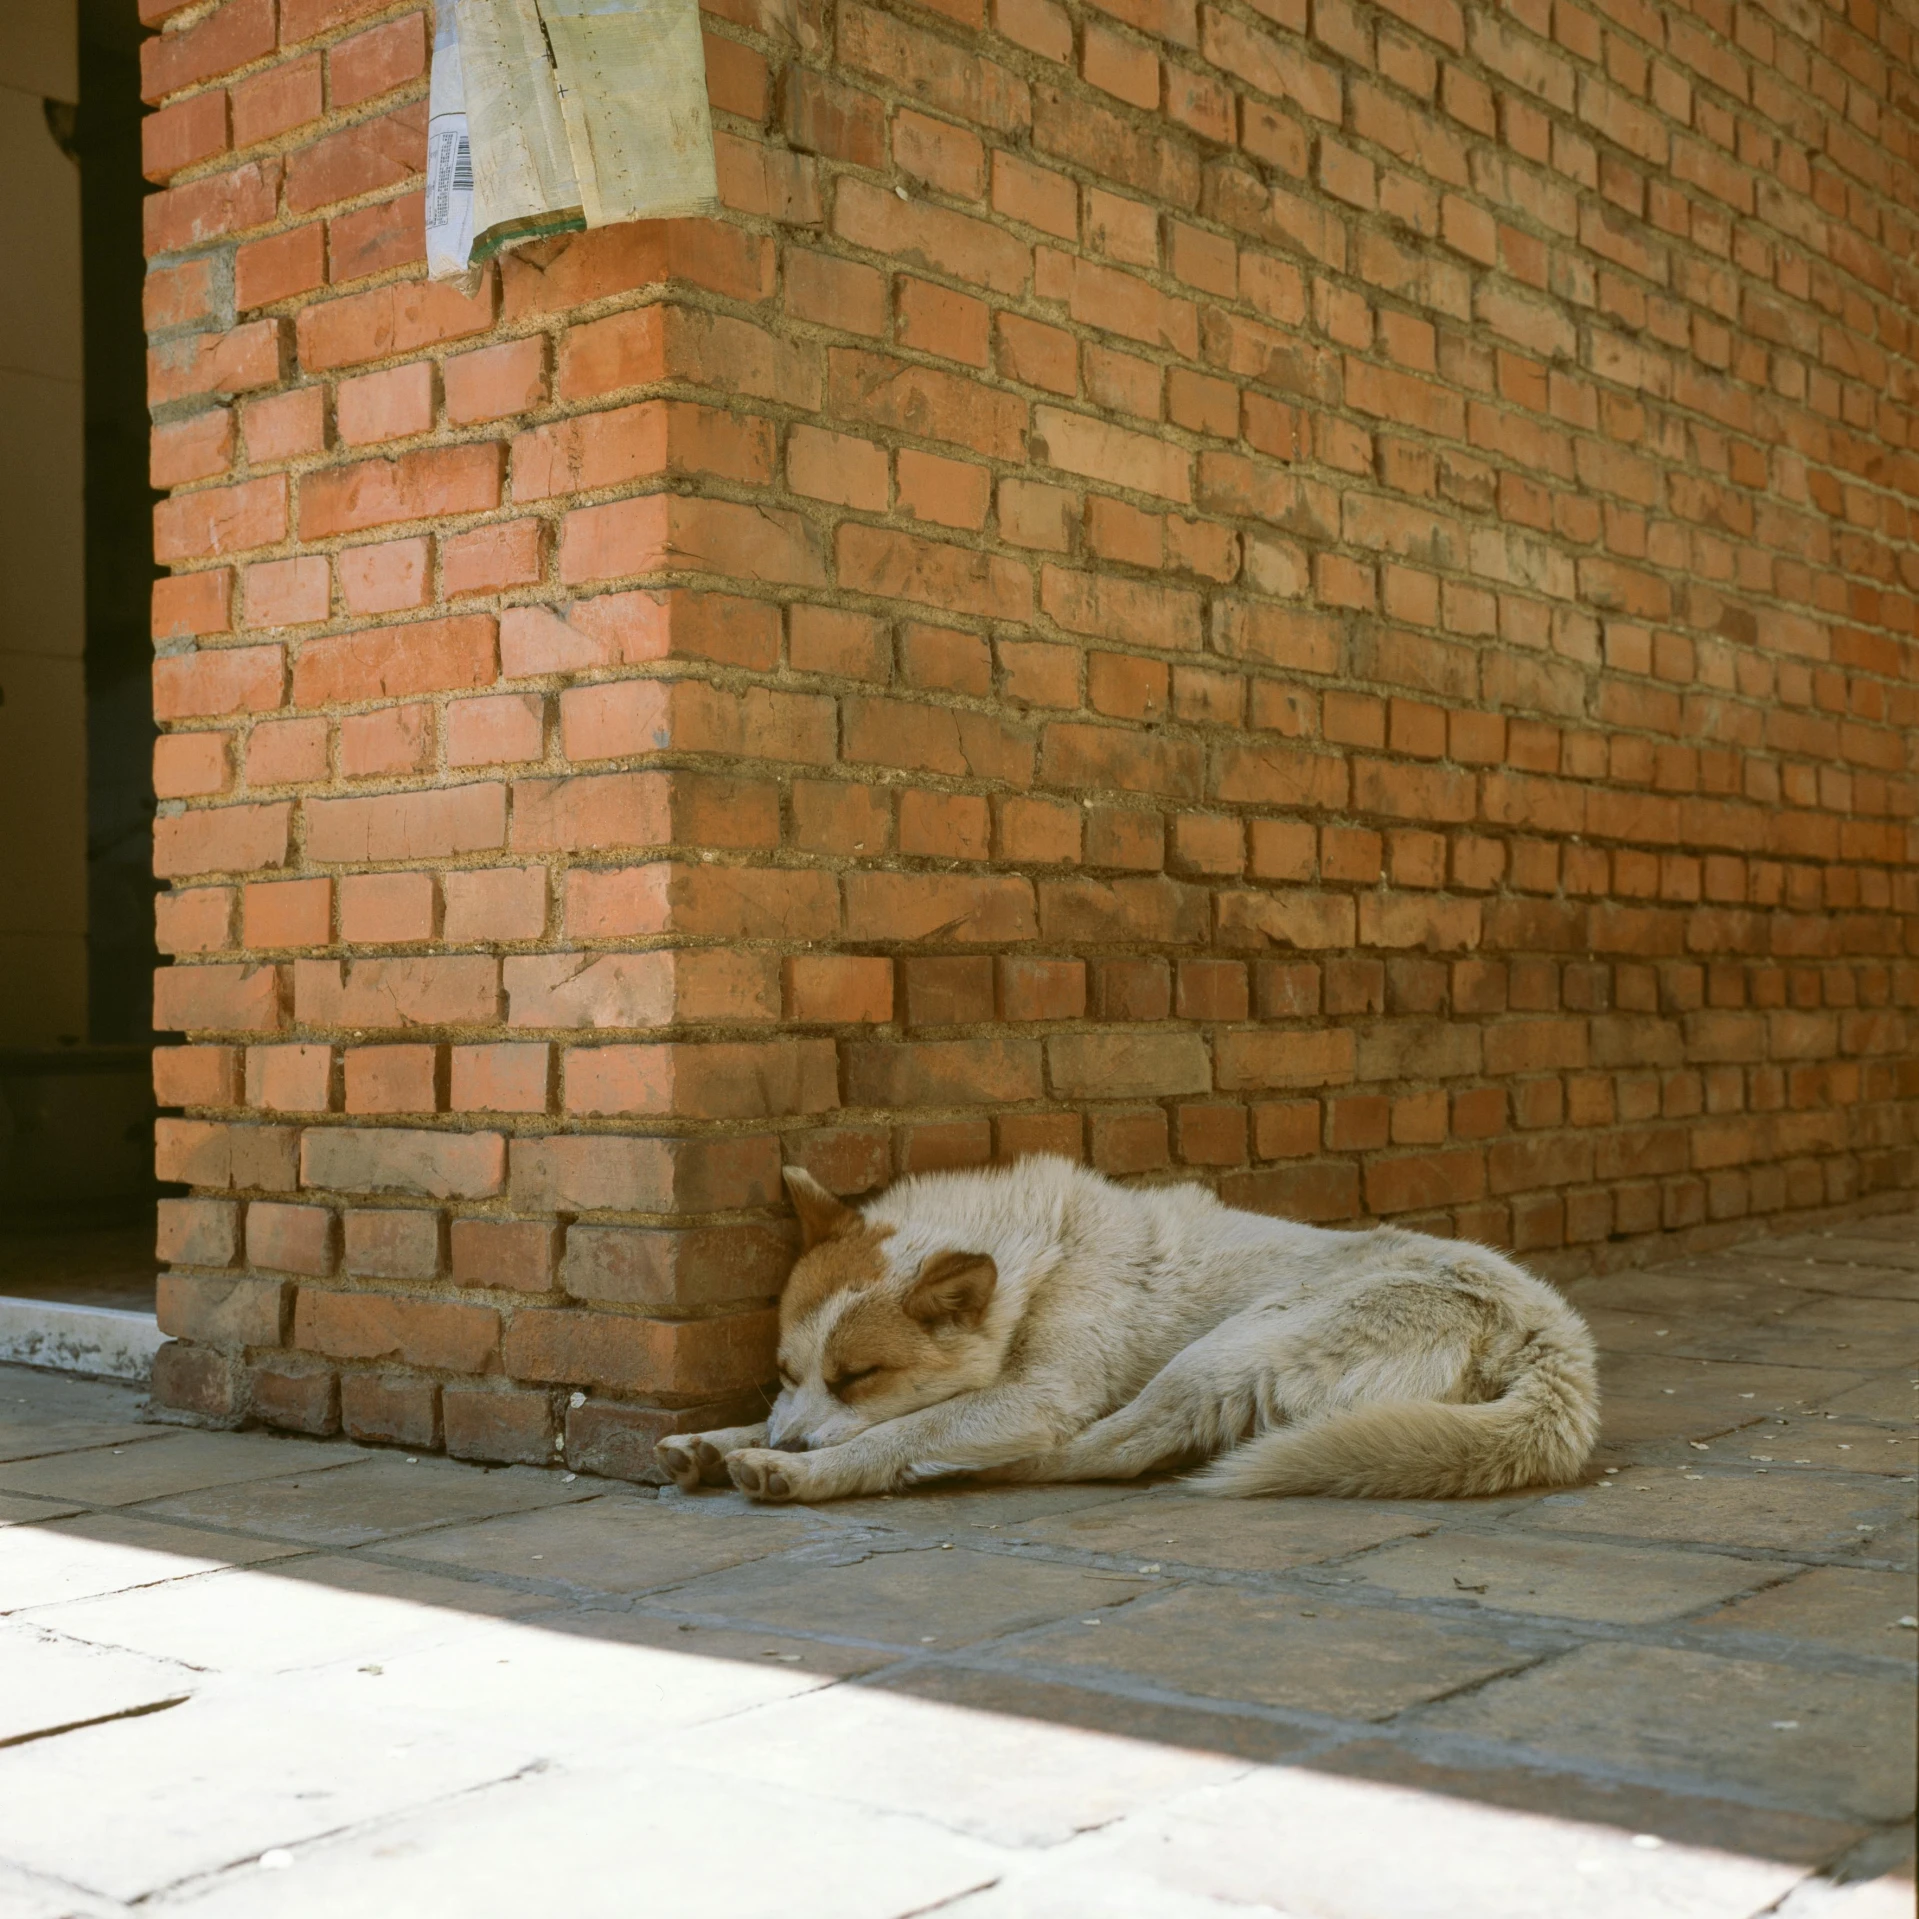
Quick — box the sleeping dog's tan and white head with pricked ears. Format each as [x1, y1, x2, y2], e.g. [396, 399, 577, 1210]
[768, 1167, 1002, 1453]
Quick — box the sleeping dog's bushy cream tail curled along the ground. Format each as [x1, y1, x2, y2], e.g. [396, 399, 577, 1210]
[1192, 1324, 1599, 1499]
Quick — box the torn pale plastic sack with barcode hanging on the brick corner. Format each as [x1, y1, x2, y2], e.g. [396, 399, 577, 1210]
[426, 0, 720, 280]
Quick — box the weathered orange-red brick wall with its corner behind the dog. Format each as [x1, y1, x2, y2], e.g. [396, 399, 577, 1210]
[142, 0, 1919, 1472]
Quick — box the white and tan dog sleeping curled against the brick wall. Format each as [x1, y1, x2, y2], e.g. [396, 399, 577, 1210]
[658, 1159, 1599, 1501]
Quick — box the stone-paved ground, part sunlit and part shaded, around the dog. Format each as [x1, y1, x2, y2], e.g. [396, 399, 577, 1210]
[0, 1217, 1919, 1919]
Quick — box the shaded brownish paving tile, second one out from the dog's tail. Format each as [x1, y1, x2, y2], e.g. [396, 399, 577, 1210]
[1006, 1587, 1537, 1719]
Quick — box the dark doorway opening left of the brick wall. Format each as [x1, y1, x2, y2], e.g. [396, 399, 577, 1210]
[0, 0, 157, 1335]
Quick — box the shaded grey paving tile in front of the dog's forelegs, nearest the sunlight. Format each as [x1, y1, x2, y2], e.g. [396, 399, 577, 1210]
[651, 1547, 1149, 1647]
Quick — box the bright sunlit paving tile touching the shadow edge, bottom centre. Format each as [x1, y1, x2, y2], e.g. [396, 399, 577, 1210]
[652, 1687, 1245, 1846]
